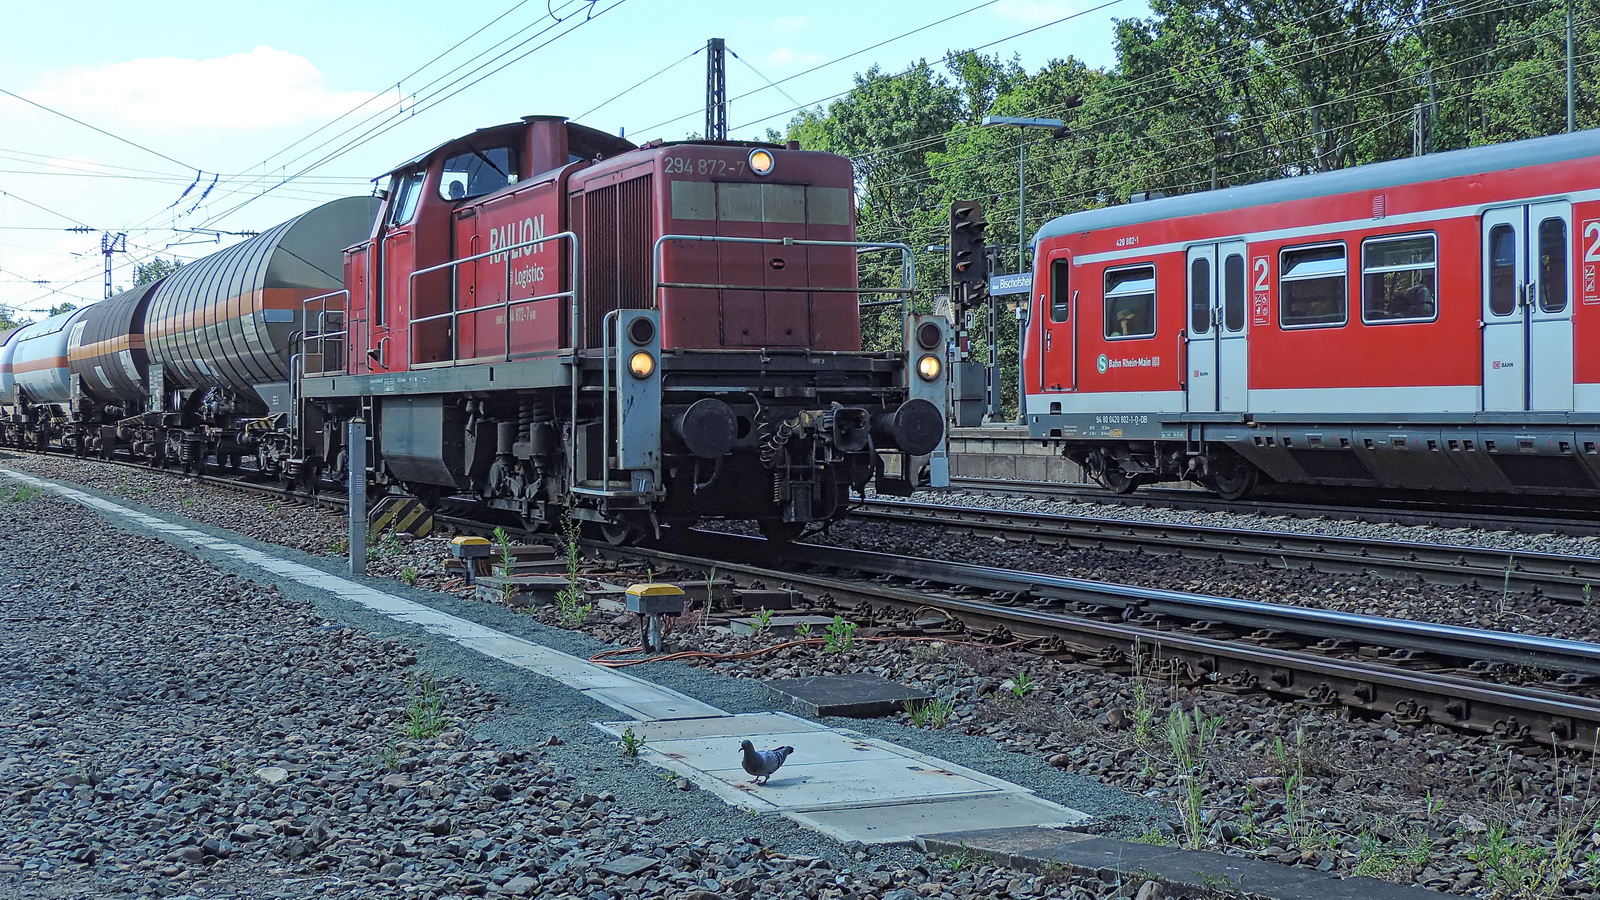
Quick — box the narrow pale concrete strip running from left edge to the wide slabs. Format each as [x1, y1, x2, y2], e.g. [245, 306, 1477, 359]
[0, 469, 728, 721]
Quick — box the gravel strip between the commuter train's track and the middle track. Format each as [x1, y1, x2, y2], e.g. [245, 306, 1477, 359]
[907, 490, 1600, 557]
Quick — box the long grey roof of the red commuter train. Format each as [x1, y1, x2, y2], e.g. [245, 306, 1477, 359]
[1034, 130, 1600, 242]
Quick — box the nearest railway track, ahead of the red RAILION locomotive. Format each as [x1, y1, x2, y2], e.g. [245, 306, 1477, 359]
[611, 533, 1600, 751]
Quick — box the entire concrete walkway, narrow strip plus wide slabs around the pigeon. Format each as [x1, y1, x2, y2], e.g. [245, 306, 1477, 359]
[0, 468, 1432, 900]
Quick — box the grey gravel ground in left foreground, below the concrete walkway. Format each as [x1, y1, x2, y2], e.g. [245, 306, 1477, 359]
[0, 470, 1203, 900]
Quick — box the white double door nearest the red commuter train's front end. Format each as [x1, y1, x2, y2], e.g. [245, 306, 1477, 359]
[1186, 240, 1250, 413]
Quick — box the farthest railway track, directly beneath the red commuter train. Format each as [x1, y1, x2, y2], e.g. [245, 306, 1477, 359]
[950, 477, 1600, 536]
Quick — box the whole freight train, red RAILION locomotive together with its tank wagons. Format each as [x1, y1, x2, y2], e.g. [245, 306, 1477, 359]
[0, 117, 949, 540]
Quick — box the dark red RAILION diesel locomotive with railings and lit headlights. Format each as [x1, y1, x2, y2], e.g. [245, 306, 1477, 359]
[292, 117, 949, 538]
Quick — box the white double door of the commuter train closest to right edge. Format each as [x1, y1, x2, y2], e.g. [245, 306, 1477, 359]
[1483, 200, 1573, 412]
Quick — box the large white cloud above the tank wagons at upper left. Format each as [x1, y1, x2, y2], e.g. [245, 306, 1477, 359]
[27, 46, 392, 130]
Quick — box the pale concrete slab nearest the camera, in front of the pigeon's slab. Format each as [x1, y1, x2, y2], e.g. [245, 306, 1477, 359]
[786, 793, 1088, 844]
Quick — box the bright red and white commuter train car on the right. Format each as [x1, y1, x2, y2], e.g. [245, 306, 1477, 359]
[1022, 131, 1600, 498]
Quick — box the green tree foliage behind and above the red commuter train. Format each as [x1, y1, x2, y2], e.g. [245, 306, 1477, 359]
[774, 0, 1600, 405]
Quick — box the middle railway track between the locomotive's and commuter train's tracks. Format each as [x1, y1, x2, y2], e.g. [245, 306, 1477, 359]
[854, 500, 1600, 604]
